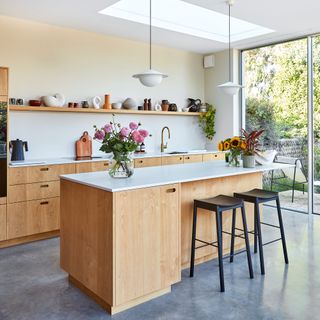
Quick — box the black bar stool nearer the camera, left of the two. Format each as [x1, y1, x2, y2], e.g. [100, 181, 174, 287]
[190, 195, 253, 292]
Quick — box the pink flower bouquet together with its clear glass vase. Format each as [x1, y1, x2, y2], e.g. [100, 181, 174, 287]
[94, 118, 149, 178]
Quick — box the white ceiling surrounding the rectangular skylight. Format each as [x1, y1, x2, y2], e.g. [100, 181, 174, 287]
[0, 0, 320, 54]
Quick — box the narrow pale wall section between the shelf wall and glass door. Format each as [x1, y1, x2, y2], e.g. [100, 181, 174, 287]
[205, 50, 240, 144]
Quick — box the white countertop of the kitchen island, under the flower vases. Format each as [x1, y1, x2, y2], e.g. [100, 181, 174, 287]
[61, 161, 293, 192]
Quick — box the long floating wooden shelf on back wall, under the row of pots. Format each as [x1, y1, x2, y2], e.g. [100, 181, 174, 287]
[9, 105, 205, 116]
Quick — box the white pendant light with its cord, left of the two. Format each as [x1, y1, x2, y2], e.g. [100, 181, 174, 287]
[133, 0, 168, 87]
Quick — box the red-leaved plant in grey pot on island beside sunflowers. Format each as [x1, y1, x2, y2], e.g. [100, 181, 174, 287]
[241, 129, 264, 168]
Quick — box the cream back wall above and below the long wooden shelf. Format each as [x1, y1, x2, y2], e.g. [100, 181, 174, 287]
[0, 16, 205, 159]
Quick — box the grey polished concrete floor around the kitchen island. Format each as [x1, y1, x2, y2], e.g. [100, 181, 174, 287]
[0, 208, 320, 320]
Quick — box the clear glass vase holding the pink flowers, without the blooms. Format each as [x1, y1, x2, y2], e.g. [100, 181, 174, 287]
[109, 152, 134, 178]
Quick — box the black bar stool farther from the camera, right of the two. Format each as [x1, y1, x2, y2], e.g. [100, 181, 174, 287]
[232, 189, 289, 274]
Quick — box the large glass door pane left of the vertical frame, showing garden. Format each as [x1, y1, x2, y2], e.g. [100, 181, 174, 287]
[242, 38, 310, 213]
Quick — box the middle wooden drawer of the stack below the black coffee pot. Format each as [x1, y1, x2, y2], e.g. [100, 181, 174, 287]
[8, 181, 60, 203]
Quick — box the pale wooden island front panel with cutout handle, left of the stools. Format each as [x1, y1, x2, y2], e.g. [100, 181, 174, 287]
[115, 185, 181, 305]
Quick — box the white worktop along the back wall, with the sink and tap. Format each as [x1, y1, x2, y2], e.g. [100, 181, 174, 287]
[9, 150, 219, 167]
